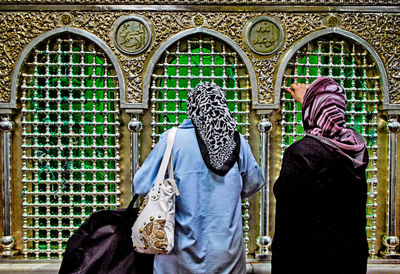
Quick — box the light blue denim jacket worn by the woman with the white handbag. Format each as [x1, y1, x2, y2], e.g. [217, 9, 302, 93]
[134, 120, 264, 273]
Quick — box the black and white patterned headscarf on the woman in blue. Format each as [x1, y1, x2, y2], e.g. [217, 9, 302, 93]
[187, 82, 240, 176]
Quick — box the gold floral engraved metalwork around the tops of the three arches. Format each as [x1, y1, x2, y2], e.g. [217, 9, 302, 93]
[0, 11, 400, 104]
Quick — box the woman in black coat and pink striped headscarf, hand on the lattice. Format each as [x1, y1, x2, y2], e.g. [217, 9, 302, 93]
[272, 77, 368, 274]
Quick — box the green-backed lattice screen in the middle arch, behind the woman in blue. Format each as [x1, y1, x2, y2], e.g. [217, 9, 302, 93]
[151, 35, 251, 253]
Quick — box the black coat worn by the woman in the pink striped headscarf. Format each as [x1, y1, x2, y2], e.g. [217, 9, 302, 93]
[272, 136, 368, 274]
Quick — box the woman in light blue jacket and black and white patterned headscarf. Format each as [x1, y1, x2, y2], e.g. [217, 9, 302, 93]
[134, 83, 264, 273]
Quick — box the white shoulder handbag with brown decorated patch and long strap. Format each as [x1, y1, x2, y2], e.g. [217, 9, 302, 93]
[132, 127, 179, 254]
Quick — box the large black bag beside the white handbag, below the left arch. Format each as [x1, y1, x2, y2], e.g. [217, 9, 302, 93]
[59, 195, 154, 274]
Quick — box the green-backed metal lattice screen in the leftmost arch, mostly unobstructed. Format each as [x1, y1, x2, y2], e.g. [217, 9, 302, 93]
[20, 34, 119, 259]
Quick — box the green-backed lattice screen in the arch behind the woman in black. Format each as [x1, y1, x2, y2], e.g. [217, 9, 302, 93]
[281, 37, 380, 254]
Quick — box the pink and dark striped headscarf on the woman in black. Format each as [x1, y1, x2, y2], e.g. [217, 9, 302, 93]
[302, 77, 368, 168]
